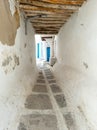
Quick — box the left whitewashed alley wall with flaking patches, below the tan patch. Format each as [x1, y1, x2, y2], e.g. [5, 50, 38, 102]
[0, 14, 37, 130]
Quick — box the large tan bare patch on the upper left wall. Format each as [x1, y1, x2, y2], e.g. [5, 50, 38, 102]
[0, 0, 20, 45]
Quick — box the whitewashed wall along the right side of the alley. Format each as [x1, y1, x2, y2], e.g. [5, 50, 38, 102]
[53, 0, 97, 130]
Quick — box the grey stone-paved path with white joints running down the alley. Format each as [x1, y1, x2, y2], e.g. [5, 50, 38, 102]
[18, 67, 75, 130]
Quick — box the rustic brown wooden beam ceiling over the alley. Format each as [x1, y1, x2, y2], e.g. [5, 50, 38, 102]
[18, 0, 86, 34]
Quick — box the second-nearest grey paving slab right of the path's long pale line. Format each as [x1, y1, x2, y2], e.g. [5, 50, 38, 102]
[54, 94, 66, 107]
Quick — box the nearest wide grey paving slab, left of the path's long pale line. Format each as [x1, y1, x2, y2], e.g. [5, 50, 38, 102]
[19, 114, 59, 130]
